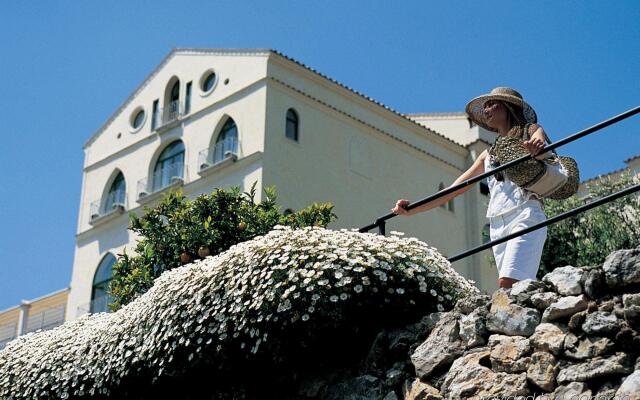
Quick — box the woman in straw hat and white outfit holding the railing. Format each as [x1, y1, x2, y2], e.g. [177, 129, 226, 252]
[391, 87, 550, 288]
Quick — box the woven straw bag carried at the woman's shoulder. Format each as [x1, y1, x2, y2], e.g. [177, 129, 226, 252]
[494, 124, 580, 200]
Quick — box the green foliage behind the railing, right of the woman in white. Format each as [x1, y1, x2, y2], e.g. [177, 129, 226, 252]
[538, 171, 640, 277]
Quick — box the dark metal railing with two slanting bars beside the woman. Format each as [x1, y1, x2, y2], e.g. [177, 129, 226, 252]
[358, 106, 640, 262]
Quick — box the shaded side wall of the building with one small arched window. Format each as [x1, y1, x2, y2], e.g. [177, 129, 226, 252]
[264, 55, 497, 290]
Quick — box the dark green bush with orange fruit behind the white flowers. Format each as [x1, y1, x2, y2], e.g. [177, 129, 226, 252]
[109, 182, 337, 311]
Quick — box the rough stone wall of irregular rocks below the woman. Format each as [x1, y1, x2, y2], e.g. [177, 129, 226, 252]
[296, 246, 640, 400]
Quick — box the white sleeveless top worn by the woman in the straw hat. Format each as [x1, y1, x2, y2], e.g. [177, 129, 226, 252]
[484, 154, 538, 218]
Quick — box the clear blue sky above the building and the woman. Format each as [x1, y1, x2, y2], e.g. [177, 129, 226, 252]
[0, 0, 640, 310]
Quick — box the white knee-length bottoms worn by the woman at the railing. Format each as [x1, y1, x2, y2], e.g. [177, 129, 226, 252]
[489, 199, 547, 280]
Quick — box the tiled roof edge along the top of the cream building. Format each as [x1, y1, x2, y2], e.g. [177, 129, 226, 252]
[82, 48, 466, 149]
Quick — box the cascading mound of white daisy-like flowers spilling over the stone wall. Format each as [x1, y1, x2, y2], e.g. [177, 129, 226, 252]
[0, 225, 478, 399]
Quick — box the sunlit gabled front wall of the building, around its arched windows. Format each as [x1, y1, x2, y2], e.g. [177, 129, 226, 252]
[66, 54, 266, 319]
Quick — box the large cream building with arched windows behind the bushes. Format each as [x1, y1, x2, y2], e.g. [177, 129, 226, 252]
[66, 49, 497, 320]
